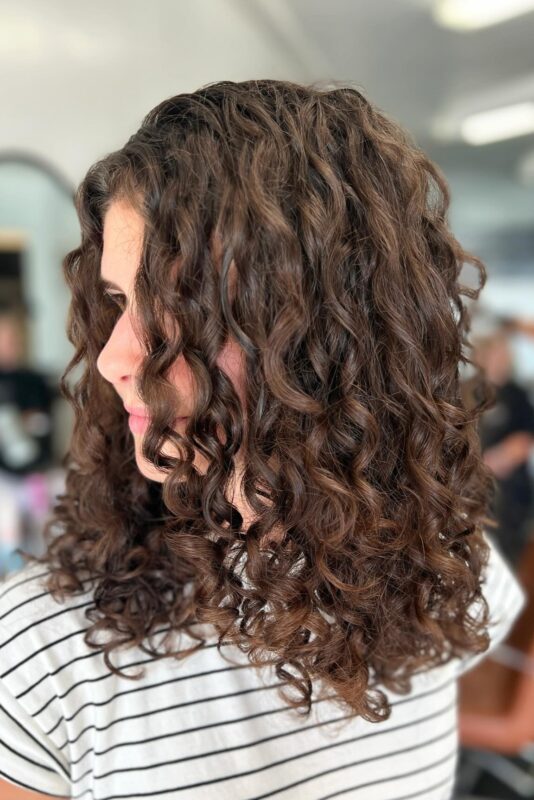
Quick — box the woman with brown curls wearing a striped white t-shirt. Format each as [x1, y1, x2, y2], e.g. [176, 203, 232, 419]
[0, 80, 524, 800]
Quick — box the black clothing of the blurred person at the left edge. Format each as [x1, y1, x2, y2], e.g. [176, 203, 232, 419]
[0, 367, 54, 475]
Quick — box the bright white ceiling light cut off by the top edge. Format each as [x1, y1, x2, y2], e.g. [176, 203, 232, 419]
[434, 0, 534, 31]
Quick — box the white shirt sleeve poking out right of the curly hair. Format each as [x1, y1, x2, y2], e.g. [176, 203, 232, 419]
[458, 532, 527, 675]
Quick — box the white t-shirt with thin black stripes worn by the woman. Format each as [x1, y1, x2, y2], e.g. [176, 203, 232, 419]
[0, 537, 526, 800]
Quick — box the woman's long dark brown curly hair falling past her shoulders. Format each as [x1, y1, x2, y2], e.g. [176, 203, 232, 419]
[19, 80, 495, 722]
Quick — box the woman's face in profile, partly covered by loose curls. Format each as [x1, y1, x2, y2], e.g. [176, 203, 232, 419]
[97, 200, 244, 482]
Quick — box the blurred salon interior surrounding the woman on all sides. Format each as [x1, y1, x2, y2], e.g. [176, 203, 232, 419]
[0, 0, 534, 798]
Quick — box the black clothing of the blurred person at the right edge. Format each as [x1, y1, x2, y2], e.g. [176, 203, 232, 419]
[479, 380, 534, 566]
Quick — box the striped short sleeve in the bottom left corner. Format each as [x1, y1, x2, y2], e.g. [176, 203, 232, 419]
[0, 680, 70, 798]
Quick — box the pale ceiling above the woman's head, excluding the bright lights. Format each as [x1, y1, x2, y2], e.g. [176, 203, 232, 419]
[0, 0, 534, 238]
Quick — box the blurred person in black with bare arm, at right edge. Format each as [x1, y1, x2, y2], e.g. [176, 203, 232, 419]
[475, 321, 534, 567]
